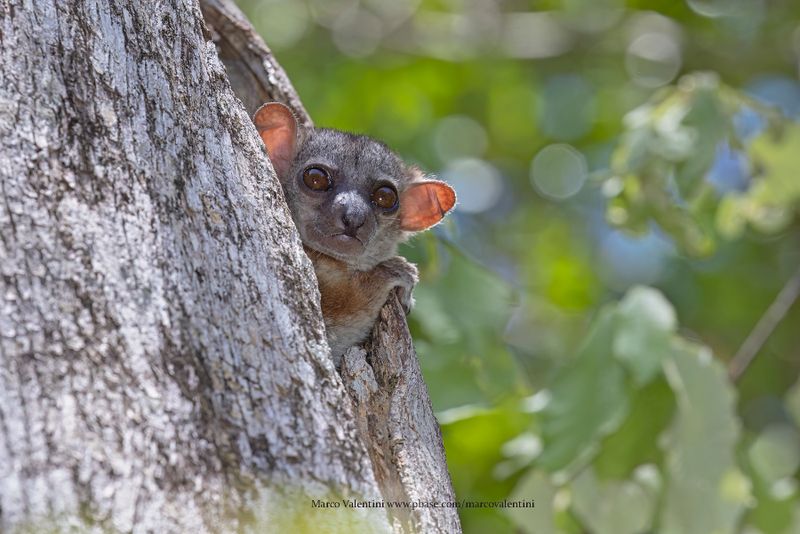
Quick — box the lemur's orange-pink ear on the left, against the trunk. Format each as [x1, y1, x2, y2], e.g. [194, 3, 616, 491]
[253, 102, 297, 177]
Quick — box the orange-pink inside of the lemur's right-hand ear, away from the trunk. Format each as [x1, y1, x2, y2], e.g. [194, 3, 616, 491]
[400, 180, 456, 232]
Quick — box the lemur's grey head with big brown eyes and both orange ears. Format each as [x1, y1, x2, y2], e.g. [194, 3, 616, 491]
[253, 102, 456, 270]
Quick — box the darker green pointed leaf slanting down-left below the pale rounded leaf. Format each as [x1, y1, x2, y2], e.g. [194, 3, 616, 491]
[537, 308, 628, 471]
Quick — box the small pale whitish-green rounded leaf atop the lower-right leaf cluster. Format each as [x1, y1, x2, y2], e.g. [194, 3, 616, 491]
[613, 287, 677, 385]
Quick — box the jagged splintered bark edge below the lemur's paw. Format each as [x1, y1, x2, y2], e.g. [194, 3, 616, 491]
[341, 297, 461, 533]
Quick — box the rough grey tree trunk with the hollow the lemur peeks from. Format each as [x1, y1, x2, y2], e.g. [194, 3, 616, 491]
[0, 0, 459, 533]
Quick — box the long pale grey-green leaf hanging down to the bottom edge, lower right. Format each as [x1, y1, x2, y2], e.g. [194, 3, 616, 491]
[659, 342, 750, 534]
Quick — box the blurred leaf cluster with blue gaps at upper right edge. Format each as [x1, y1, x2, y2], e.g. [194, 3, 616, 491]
[603, 73, 800, 256]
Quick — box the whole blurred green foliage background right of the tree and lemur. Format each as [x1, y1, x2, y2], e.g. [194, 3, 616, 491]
[239, 0, 800, 534]
